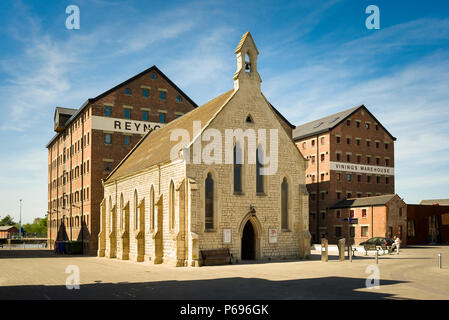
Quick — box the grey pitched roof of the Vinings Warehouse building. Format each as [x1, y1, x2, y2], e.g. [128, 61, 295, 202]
[293, 104, 396, 140]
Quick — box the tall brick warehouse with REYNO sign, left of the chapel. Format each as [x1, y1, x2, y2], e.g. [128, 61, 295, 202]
[47, 66, 197, 254]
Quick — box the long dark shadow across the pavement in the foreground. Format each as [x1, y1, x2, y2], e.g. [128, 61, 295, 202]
[0, 277, 405, 300]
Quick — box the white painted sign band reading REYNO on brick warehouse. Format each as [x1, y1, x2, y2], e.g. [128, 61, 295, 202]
[92, 116, 165, 134]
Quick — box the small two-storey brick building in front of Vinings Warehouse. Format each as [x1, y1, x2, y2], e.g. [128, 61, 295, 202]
[325, 194, 407, 246]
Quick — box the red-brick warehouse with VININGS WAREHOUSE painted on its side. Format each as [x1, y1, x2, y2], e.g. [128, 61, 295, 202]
[293, 105, 396, 243]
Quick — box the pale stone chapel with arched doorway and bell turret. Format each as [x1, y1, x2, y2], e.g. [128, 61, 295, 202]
[98, 32, 310, 266]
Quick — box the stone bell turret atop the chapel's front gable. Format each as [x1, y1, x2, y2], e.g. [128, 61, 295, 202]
[234, 31, 262, 91]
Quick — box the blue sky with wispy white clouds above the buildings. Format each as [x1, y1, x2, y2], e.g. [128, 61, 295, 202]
[0, 0, 449, 222]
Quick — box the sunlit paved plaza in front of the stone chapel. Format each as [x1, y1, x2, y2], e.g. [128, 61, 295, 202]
[0, 246, 449, 299]
